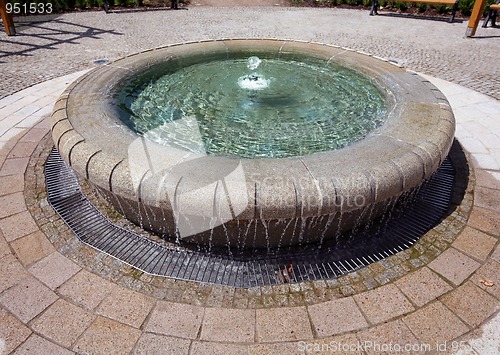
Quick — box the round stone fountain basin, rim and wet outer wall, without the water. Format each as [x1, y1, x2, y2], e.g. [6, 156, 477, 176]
[52, 39, 455, 249]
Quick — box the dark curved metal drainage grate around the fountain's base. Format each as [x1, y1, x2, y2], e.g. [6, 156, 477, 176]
[45, 148, 454, 288]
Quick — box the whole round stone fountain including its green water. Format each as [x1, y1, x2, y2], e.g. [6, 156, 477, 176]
[52, 40, 454, 250]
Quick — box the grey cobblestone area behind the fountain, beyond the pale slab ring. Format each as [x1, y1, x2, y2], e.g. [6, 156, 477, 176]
[0, 5, 500, 99]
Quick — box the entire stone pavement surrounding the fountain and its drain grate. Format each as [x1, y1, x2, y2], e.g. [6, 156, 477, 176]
[0, 7, 500, 355]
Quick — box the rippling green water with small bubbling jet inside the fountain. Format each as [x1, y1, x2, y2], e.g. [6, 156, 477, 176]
[119, 56, 387, 158]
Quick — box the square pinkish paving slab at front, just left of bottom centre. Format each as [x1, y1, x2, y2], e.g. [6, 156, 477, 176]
[200, 308, 255, 343]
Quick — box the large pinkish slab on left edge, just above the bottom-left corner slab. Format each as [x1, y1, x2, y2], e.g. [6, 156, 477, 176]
[0, 278, 57, 323]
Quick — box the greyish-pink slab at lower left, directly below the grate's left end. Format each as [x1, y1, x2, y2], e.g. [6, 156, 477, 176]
[29, 252, 81, 290]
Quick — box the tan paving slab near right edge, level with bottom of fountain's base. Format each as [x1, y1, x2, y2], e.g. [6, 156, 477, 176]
[452, 226, 497, 260]
